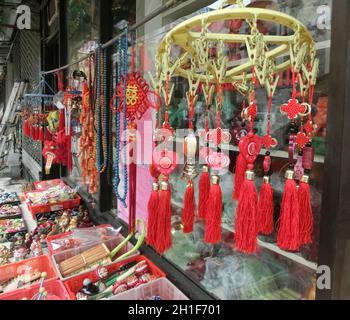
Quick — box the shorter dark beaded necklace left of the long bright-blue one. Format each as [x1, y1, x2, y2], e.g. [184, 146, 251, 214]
[96, 46, 109, 173]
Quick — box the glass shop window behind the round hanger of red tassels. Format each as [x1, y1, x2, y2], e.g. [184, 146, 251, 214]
[120, 1, 331, 300]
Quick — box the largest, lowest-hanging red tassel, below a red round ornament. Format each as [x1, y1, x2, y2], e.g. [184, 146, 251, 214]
[235, 171, 258, 254]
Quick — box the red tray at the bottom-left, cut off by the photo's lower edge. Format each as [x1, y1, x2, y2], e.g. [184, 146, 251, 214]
[0, 280, 71, 301]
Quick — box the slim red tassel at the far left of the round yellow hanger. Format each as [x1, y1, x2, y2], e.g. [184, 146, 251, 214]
[147, 183, 159, 246]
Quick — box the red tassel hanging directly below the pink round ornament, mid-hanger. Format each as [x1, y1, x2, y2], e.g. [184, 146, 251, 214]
[204, 176, 222, 244]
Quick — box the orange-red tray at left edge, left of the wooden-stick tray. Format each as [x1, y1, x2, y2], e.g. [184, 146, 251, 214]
[0, 256, 58, 297]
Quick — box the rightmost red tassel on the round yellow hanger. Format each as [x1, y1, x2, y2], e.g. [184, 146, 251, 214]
[298, 176, 313, 246]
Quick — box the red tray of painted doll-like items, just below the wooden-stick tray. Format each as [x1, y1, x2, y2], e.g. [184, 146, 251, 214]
[64, 255, 166, 300]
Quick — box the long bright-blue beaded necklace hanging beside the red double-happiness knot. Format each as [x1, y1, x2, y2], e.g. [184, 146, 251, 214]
[113, 26, 128, 208]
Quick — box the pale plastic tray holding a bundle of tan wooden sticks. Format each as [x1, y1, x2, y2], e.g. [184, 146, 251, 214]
[52, 235, 140, 281]
